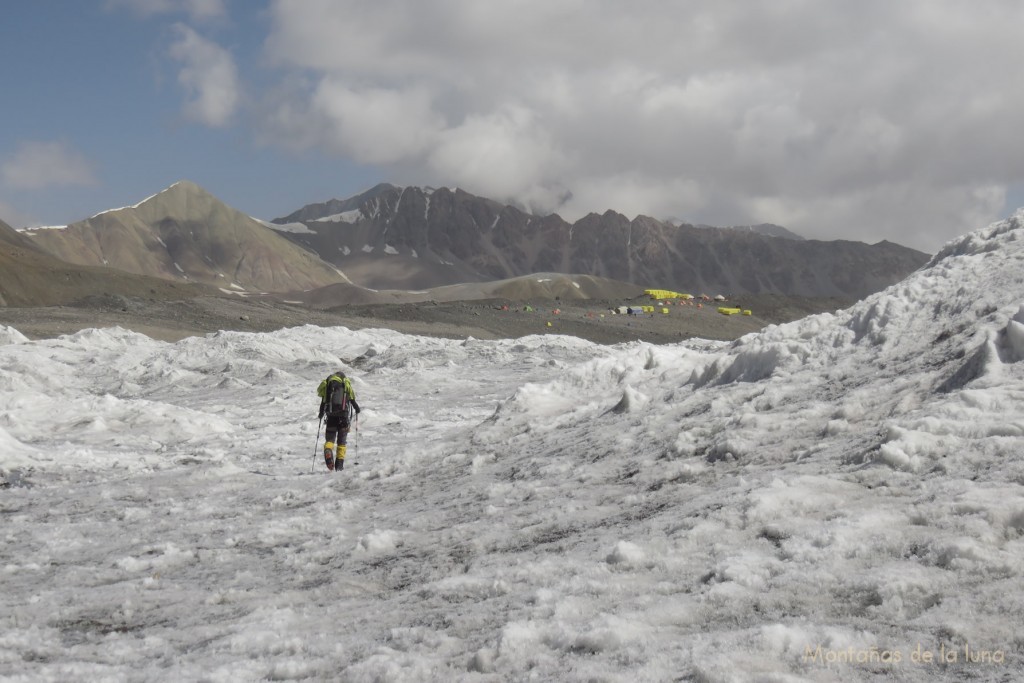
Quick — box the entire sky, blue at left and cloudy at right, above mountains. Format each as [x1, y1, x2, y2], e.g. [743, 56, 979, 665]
[0, 0, 1024, 251]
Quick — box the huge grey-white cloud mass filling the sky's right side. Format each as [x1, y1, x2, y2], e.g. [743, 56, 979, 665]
[258, 0, 1024, 250]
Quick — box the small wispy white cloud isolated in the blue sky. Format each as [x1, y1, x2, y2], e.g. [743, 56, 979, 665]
[170, 24, 241, 128]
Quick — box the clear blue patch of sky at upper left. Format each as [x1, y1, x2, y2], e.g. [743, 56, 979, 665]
[0, 0, 383, 224]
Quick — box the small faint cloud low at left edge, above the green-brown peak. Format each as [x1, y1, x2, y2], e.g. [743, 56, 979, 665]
[0, 140, 96, 189]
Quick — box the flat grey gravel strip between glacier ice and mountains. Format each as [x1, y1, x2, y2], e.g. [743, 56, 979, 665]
[0, 294, 853, 344]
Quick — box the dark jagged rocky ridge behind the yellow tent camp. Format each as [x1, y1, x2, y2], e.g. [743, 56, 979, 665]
[274, 185, 929, 299]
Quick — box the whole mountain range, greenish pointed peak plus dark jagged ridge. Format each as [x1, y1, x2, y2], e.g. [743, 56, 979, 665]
[0, 180, 928, 305]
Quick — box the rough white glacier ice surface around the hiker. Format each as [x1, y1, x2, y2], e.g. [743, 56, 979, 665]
[0, 212, 1024, 682]
